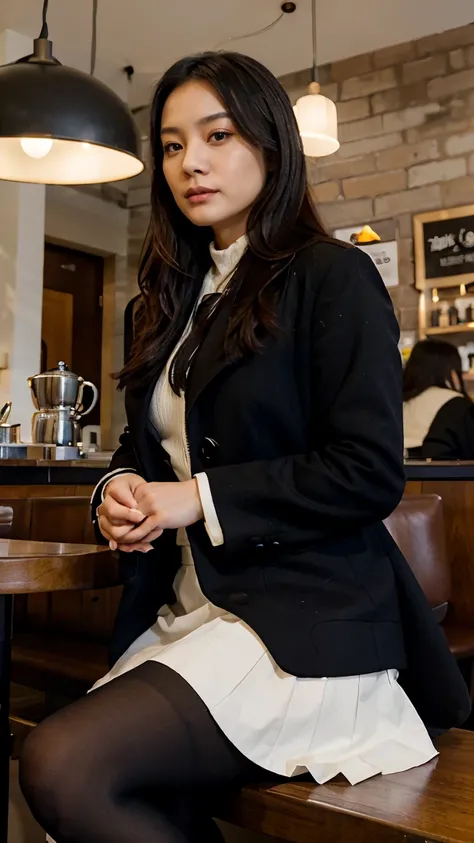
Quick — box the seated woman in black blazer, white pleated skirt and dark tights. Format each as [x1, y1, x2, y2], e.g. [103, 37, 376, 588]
[17, 53, 469, 843]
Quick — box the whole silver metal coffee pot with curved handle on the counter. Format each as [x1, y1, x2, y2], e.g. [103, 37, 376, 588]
[28, 361, 99, 447]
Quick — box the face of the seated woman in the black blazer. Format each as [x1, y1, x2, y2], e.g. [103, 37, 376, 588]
[161, 80, 266, 249]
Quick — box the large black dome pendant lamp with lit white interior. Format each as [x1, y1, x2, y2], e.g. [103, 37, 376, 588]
[0, 0, 143, 184]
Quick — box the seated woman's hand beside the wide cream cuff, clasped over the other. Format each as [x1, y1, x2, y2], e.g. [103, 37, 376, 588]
[113, 480, 204, 552]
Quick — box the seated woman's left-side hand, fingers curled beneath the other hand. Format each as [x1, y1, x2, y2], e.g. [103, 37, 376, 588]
[97, 474, 151, 553]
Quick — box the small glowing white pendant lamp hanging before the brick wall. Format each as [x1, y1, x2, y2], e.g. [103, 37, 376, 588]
[293, 0, 340, 158]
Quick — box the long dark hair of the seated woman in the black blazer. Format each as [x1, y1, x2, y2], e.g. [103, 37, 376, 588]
[118, 52, 332, 393]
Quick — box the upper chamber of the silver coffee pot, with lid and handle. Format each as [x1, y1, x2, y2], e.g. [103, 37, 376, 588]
[28, 360, 99, 416]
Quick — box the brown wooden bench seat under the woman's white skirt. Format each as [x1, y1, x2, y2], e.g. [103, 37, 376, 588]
[218, 729, 474, 843]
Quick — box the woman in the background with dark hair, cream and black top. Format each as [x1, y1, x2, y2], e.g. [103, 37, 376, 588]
[403, 340, 474, 460]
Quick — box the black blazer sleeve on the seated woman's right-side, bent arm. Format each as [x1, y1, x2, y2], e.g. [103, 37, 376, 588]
[206, 249, 405, 552]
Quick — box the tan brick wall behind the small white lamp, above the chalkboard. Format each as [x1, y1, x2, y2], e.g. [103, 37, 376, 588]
[281, 24, 474, 330]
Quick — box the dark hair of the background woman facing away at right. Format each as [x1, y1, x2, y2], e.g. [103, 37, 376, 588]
[403, 339, 467, 401]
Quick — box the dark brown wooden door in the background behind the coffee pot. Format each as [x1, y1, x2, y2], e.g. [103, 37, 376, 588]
[42, 243, 104, 424]
